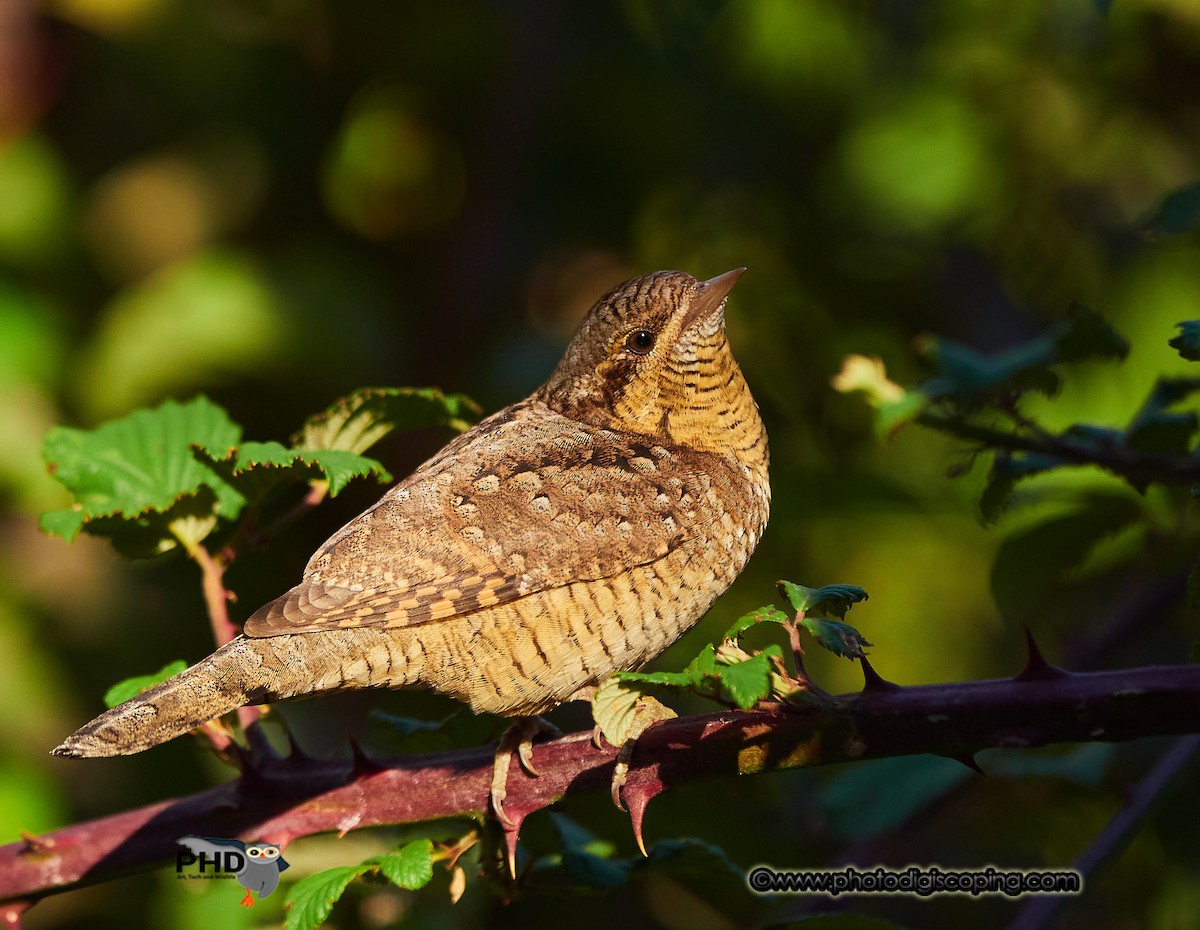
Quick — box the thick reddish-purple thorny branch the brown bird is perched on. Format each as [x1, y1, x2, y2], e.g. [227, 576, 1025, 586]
[7, 650, 1200, 901]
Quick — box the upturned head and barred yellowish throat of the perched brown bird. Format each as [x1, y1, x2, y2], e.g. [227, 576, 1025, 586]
[536, 268, 757, 450]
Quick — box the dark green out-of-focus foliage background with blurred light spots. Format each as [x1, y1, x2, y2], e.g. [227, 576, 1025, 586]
[0, 0, 1200, 930]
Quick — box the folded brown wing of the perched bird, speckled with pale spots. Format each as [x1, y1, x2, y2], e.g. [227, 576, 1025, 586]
[245, 402, 704, 636]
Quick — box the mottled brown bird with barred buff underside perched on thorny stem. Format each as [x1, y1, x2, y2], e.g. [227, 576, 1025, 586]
[53, 269, 770, 820]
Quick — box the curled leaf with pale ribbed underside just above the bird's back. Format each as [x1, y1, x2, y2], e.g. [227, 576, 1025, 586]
[292, 388, 480, 452]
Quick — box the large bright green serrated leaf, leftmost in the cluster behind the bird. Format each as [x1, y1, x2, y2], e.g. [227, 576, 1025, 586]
[41, 396, 246, 554]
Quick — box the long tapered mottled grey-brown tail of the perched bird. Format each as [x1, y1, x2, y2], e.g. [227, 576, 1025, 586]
[52, 630, 415, 758]
